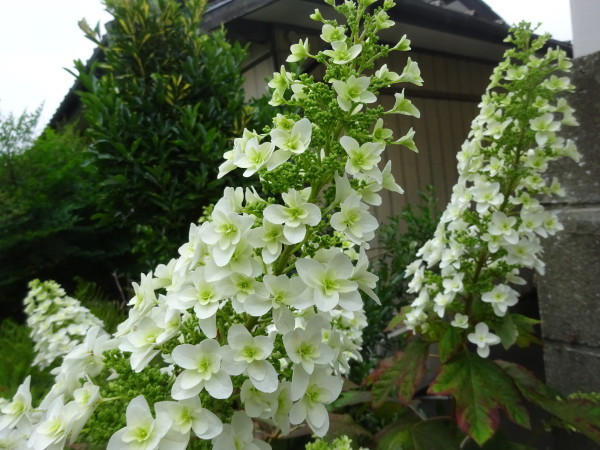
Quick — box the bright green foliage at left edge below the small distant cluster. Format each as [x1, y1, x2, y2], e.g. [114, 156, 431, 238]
[0, 319, 54, 404]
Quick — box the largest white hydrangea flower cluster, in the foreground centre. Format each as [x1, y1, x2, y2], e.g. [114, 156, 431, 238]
[0, 0, 422, 450]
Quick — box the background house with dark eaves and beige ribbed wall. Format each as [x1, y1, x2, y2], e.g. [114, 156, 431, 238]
[50, 0, 576, 221]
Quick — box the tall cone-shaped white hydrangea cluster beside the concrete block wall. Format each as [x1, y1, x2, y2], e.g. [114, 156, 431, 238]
[405, 24, 579, 357]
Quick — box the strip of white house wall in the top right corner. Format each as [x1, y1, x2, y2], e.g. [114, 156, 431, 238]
[571, 0, 600, 58]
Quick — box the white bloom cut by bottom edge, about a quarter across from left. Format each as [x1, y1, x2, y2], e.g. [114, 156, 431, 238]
[107, 395, 172, 450]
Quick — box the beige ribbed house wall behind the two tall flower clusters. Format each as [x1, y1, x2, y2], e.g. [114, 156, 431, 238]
[245, 25, 495, 221]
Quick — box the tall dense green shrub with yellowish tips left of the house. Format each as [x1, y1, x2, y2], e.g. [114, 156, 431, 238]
[76, 0, 258, 267]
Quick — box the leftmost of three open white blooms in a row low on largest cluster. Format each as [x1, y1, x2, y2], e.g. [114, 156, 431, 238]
[171, 339, 233, 400]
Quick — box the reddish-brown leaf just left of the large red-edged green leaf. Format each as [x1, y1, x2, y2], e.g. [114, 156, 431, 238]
[372, 338, 430, 407]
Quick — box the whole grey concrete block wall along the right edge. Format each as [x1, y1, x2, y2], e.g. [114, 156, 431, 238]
[537, 52, 600, 450]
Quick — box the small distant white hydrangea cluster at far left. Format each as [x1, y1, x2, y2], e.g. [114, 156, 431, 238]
[24, 280, 104, 369]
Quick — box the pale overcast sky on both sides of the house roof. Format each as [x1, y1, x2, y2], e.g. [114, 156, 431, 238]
[0, 0, 572, 132]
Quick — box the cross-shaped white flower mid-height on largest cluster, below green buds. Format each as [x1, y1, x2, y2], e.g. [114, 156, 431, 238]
[263, 188, 321, 244]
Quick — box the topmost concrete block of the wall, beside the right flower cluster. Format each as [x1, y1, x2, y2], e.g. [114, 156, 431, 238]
[548, 53, 600, 204]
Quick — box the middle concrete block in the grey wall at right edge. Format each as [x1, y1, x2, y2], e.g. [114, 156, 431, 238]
[538, 207, 600, 347]
